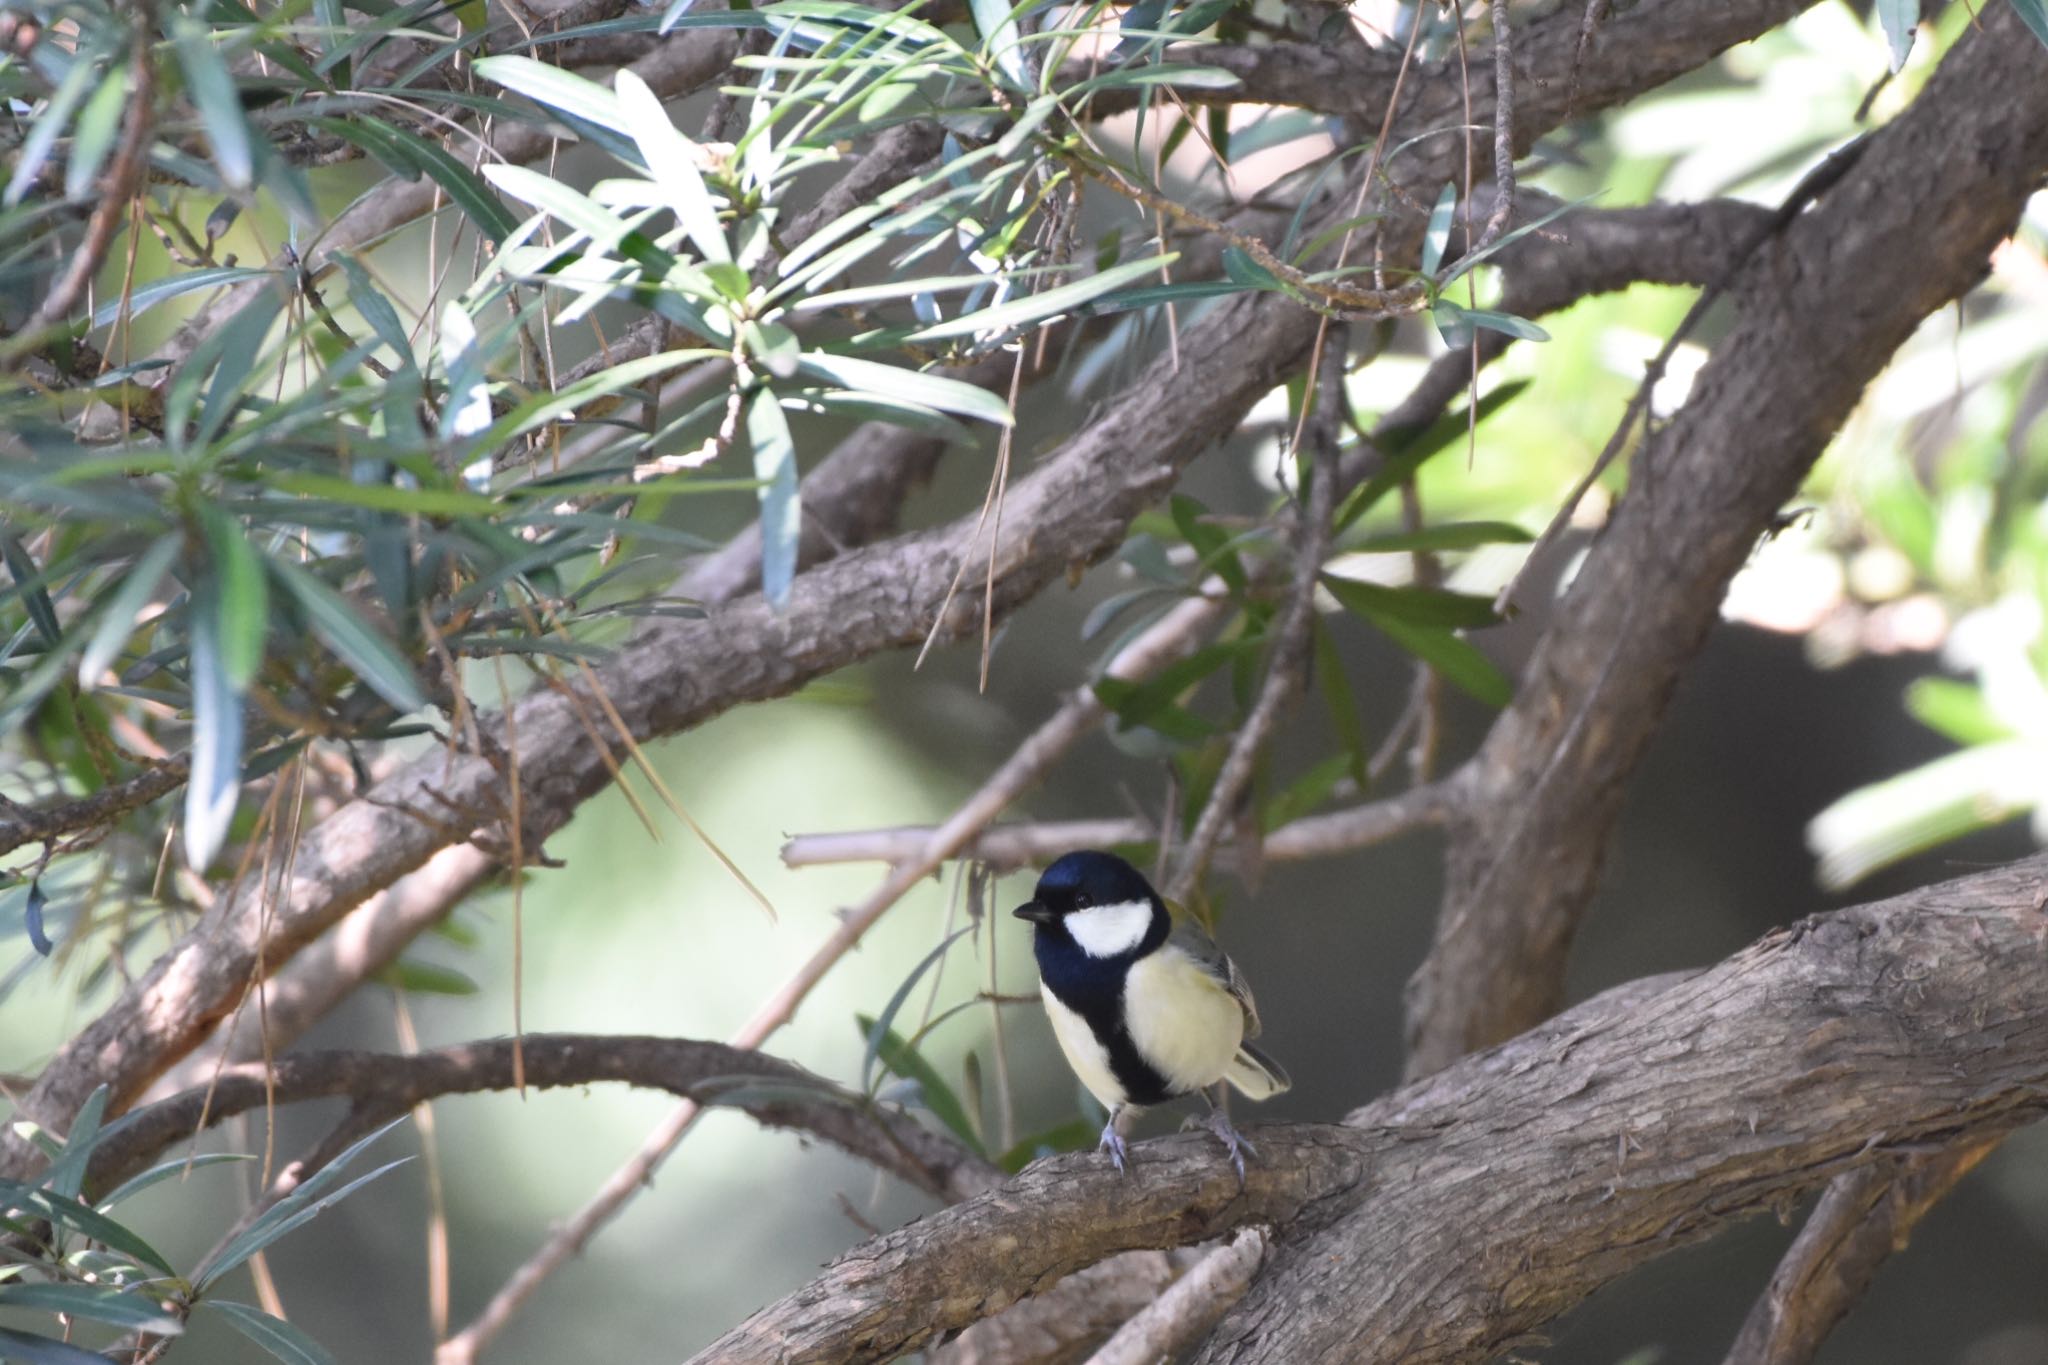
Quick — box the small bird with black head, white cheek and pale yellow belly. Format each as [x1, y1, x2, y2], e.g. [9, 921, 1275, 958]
[1016, 849, 1290, 1181]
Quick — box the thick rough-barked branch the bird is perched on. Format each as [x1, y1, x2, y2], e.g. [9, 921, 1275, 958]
[696, 857, 2048, 1365]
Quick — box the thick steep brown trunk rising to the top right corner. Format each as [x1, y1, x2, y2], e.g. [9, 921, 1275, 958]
[1409, 8, 2048, 1074]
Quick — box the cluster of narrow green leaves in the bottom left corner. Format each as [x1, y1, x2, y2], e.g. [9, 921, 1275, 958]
[0, 1087, 408, 1365]
